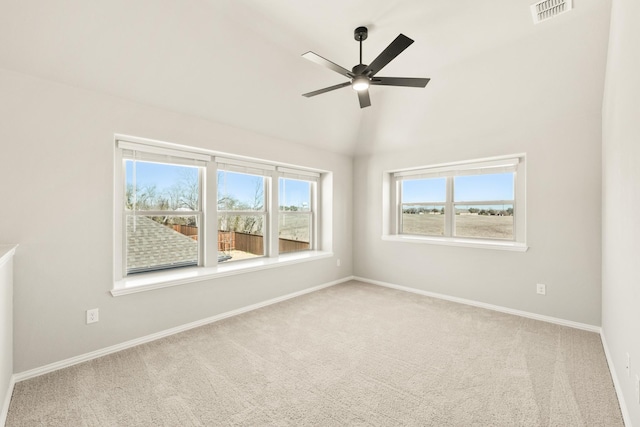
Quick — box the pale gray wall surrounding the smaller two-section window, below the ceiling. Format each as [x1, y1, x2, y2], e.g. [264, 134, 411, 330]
[354, 111, 601, 326]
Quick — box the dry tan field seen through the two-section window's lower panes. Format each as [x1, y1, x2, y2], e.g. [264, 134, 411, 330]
[402, 214, 513, 240]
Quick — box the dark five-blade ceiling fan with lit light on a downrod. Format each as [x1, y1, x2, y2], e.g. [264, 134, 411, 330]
[302, 27, 430, 108]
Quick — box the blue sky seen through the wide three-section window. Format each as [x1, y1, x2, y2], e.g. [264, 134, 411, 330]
[125, 161, 311, 207]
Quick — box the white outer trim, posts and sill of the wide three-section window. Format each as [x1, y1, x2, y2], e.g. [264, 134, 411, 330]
[111, 134, 333, 296]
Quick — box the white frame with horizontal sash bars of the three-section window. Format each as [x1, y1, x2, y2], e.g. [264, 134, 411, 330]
[111, 135, 332, 296]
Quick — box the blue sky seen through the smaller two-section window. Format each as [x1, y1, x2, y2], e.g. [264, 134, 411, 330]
[402, 173, 514, 203]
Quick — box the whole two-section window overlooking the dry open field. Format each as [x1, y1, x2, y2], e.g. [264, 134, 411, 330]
[387, 155, 525, 248]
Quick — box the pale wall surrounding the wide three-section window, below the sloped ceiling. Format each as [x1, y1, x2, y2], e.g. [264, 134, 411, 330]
[0, 70, 352, 372]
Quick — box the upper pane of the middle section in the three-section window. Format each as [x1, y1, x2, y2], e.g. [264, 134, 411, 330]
[218, 171, 265, 211]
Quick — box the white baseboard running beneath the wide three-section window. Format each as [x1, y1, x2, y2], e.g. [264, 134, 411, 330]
[13, 276, 353, 384]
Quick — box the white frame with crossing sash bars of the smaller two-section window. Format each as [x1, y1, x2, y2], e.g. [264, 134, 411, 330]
[382, 154, 528, 252]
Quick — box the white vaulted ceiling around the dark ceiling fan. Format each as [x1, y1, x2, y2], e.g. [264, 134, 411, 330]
[0, 0, 610, 154]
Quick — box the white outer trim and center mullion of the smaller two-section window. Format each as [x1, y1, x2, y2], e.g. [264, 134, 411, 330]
[381, 153, 529, 252]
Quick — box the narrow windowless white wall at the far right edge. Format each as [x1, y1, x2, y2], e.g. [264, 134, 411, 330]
[602, 0, 640, 425]
